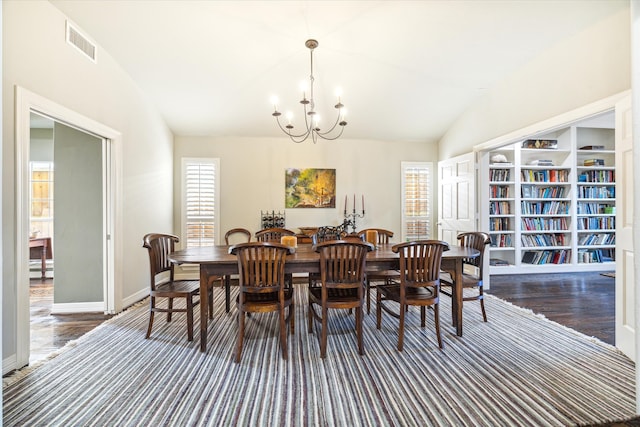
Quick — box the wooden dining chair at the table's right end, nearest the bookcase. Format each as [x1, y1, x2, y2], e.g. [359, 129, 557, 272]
[440, 231, 491, 324]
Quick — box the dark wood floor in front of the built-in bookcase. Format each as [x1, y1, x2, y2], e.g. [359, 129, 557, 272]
[487, 272, 615, 345]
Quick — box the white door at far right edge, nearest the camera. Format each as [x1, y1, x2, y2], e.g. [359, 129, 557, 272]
[616, 96, 636, 361]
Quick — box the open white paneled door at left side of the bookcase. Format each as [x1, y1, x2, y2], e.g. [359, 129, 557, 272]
[438, 153, 476, 244]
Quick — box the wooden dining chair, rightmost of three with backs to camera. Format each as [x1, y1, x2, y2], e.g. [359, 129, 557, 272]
[376, 240, 449, 351]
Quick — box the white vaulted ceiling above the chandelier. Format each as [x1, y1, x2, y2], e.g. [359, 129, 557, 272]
[51, 0, 628, 141]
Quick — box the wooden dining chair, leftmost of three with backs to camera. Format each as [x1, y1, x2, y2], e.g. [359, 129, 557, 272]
[229, 242, 295, 363]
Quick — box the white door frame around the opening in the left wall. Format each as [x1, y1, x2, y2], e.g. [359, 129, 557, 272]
[15, 86, 123, 367]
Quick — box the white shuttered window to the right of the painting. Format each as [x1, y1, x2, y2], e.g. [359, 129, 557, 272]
[401, 162, 433, 241]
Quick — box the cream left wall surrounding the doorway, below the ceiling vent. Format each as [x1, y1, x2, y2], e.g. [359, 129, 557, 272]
[2, 1, 173, 360]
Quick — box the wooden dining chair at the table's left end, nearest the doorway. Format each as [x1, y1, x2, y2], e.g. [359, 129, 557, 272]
[142, 233, 213, 341]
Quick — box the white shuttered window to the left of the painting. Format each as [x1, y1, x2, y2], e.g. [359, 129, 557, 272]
[182, 158, 220, 248]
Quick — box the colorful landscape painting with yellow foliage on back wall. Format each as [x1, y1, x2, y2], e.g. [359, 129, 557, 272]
[284, 168, 336, 209]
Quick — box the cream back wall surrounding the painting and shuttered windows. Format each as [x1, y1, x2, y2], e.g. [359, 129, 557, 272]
[174, 137, 438, 241]
